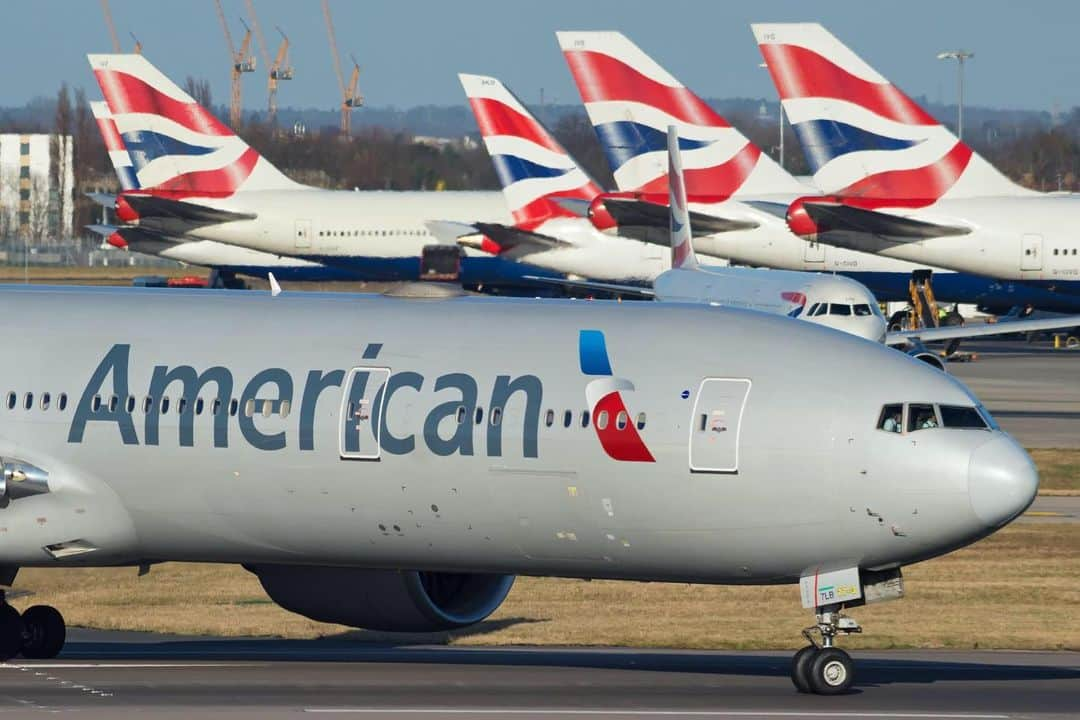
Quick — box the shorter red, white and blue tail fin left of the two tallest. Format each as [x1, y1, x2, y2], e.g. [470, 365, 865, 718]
[458, 74, 602, 230]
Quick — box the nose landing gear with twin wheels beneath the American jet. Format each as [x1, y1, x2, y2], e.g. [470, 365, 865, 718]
[792, 606, 863, 695]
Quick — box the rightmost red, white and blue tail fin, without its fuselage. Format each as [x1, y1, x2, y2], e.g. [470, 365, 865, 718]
[752, 23, 1029, 202]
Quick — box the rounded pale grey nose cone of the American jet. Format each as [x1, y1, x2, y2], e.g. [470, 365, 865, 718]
[968, 435, 1039, 528]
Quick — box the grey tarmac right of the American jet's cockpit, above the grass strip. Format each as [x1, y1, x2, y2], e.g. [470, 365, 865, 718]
[948, 340, 1080, 448]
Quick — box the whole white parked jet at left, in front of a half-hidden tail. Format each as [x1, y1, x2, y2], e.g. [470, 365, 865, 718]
[89, 55, 565, 293]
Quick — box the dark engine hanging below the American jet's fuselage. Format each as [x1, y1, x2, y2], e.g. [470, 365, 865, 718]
[245, 565, 514, 633]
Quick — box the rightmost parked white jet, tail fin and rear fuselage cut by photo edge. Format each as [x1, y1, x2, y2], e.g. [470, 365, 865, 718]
[753, 23, 1080, 295]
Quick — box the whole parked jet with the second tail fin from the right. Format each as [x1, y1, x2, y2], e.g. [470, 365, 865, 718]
[557, 32, 1080, 313]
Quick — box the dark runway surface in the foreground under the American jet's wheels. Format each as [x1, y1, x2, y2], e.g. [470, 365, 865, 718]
[0, 630, 1080, 720]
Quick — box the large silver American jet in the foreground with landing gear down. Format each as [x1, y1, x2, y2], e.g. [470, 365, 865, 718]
[0, 286, 1038, 694]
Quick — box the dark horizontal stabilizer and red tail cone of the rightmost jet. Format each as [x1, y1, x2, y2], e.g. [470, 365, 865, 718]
[788, 200, 971, 253]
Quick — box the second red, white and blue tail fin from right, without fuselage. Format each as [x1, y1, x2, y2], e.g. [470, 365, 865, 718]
[556, 32, 807, 201]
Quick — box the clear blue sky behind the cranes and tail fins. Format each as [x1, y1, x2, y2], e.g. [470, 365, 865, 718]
[0, 0, 1080, 110]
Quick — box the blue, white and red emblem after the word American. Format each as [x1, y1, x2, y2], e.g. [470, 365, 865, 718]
[578, 330, 656, 462]
